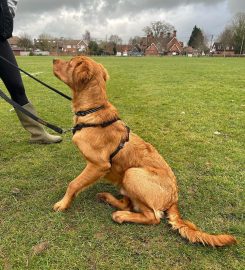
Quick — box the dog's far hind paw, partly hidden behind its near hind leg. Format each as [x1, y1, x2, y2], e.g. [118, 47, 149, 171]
[96, 192, 131, 210]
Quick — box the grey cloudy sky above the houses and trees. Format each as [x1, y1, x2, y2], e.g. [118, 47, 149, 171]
[14, 0, 245, 43]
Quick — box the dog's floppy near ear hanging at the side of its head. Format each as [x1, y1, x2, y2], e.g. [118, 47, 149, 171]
[73, 61, 94, 87]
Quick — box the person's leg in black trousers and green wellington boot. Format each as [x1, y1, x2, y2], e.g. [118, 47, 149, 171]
[0, 41, 62, 143]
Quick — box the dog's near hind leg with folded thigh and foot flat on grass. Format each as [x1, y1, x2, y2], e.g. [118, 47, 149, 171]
[112, 168, 173, 224]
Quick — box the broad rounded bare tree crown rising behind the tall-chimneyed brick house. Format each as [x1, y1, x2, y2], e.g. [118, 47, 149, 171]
[143, 21, 174, 38]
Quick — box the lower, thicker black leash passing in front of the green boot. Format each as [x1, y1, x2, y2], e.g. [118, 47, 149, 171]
[0, 89, 64, 134]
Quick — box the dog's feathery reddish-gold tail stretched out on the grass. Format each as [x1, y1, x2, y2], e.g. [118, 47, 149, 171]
[167, 204, 236, 247]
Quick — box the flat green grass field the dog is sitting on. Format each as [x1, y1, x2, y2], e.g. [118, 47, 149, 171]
[0, 57, 245, 270]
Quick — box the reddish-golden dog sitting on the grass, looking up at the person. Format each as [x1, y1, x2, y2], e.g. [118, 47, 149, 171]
[53, 56, 236, 246]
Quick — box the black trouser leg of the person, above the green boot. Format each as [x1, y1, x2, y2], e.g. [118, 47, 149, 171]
[0, 40, 29, 106]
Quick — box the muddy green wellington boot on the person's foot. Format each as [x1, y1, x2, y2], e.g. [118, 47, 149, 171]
[15, 103, 62, 144]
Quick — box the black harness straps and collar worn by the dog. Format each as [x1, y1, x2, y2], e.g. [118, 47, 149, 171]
[72, 105, 130, 163]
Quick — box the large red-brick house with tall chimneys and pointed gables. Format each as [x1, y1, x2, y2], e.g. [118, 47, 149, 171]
[139, 30, 183, 55]
